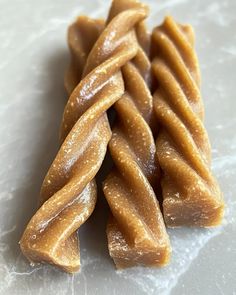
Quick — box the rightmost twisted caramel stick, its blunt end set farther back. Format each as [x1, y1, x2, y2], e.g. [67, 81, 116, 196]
[152, 17, 224, 227]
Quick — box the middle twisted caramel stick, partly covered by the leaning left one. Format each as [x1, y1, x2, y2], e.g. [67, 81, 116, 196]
[103, 1, 170, 268]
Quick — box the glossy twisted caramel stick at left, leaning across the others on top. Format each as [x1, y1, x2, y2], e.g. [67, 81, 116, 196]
[20, 0, 147, 272]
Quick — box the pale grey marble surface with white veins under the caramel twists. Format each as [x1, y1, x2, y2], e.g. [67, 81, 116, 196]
[0, 0, 236, 295]
